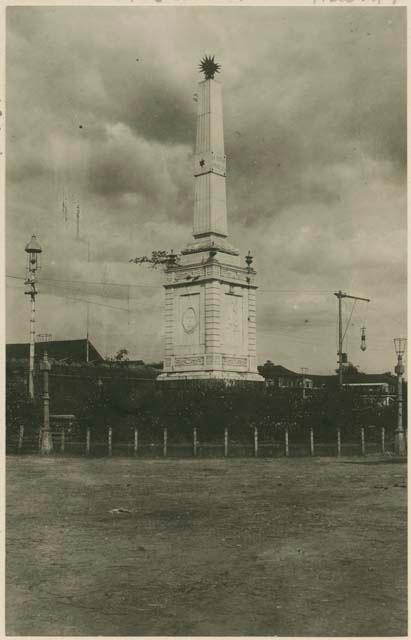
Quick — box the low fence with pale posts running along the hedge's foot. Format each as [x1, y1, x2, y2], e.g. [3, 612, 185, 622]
[6, 425, 400, 458]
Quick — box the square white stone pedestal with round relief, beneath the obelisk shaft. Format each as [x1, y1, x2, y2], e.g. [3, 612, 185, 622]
[158, 249, 263, 382]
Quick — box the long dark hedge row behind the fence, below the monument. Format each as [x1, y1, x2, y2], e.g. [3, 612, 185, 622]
[6, 371, 405, 441]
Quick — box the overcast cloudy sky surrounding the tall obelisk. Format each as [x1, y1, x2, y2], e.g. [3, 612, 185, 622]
[6, 6, 406, 372]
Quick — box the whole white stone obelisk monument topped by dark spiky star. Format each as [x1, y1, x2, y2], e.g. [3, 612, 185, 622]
[158, 56, 263, 382]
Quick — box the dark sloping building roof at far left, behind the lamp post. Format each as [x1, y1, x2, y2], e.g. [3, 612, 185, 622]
[6, 338, 104, 362]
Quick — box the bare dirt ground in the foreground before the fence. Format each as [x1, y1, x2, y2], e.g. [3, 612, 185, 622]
[6, 456, 407, 636]
